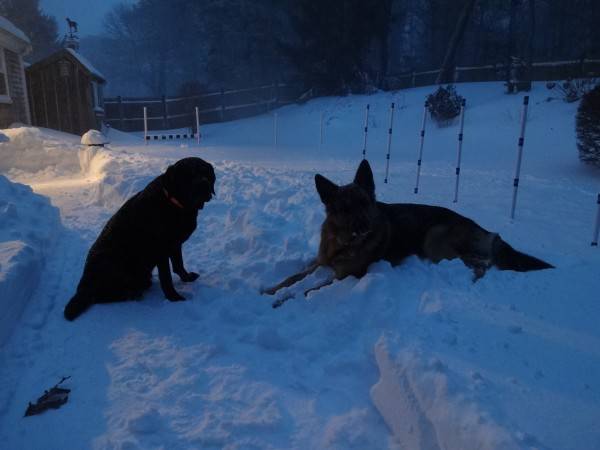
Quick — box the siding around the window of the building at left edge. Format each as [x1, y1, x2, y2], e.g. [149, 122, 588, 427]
[0, 49, 30, 128]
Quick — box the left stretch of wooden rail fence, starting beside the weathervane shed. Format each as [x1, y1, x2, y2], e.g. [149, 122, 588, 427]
[104, 84, 301, 132]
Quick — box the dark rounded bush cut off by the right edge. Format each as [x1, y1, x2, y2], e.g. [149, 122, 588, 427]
[576, 85, 600, 167]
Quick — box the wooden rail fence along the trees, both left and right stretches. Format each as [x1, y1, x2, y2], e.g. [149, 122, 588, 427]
[104, 59, 600, 132]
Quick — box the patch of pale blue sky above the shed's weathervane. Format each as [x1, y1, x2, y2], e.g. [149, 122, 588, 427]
[40, 0, 134, 37]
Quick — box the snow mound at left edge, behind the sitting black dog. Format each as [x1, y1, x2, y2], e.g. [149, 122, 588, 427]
[0, 175, 62, 345]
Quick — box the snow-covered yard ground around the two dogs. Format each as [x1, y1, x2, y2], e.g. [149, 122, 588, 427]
[0, 83, 600, 450]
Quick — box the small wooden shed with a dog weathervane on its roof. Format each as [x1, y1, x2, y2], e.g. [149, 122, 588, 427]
[25, 48, 106, 135]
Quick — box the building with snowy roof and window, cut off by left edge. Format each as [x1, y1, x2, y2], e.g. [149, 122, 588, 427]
[0, 16, 31, 128]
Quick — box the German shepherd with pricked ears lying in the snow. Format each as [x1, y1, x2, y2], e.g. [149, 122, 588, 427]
[262, 159, 553, 307]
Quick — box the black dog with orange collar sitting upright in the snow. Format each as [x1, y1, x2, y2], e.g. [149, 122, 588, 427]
[64, 158, 215, 320]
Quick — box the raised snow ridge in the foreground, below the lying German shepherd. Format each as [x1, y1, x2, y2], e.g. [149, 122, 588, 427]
[371, 336, 520, 450]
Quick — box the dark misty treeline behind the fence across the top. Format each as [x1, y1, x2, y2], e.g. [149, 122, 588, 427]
[0, 0, 600, 96]
